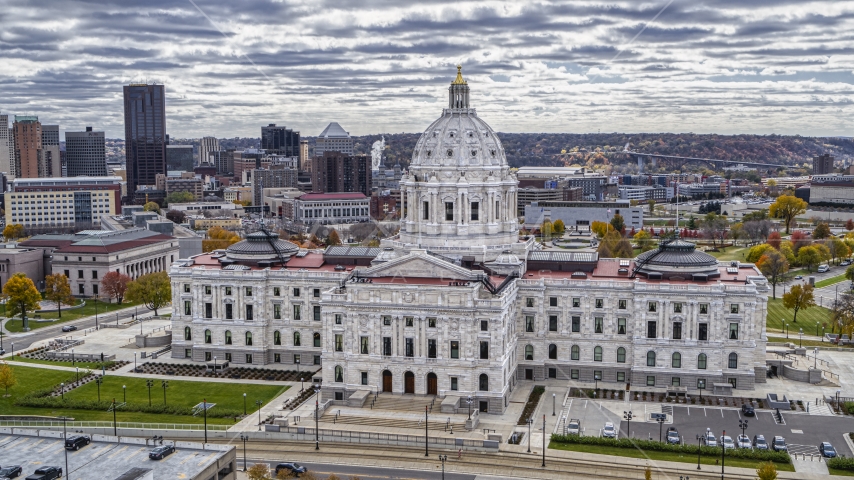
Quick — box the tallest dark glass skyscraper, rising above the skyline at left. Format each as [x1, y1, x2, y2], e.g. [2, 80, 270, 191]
[124, 84, 167, 197]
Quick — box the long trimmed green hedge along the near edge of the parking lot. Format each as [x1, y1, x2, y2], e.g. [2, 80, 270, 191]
[552, 435, 791, 463]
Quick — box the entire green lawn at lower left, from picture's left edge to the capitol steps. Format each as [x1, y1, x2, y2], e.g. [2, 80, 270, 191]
[0, 365, 288, 425]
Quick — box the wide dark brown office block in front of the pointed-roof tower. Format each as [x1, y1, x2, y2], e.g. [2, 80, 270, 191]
[311, 151, 372, 196]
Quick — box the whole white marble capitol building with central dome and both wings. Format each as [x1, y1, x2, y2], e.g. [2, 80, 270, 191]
[171, 67, 767, 413]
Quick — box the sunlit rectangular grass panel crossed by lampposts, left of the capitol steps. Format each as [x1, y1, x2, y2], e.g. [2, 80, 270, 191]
[65, 375, 288, 412]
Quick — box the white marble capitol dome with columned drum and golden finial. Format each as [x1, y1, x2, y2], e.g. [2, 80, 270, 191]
[399, 66, 524, 260]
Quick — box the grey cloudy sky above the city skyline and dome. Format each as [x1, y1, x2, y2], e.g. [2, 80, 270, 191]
[0, 0, 854, 138]
